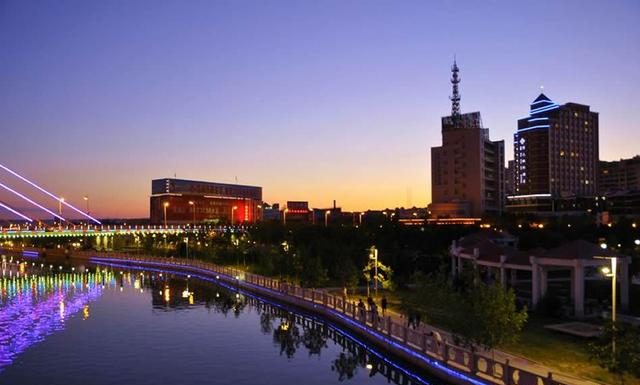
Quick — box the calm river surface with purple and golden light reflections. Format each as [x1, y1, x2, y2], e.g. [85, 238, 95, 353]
[0, 260, 442, 385]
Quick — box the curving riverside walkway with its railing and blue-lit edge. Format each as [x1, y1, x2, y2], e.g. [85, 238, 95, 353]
[73, 252, 596, 385]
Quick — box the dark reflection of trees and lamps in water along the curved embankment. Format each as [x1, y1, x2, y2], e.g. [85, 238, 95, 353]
[100, 271, 438, 385]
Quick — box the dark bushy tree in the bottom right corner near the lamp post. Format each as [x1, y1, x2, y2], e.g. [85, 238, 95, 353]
[589, 322, 640, 384]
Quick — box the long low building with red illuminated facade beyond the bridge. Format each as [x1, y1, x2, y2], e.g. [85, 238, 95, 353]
[150, 178, 262, 225]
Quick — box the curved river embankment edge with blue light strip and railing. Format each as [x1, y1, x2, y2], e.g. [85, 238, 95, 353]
[73, 253, 556, 385]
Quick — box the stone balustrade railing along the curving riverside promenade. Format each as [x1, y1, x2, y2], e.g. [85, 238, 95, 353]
[73, 251, 586, 385]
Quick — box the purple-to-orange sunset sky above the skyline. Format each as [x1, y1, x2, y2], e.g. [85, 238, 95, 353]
[0, 0, 640, 218]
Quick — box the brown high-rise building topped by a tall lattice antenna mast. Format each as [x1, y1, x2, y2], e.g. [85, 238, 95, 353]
[429, 61, 504, 218]
